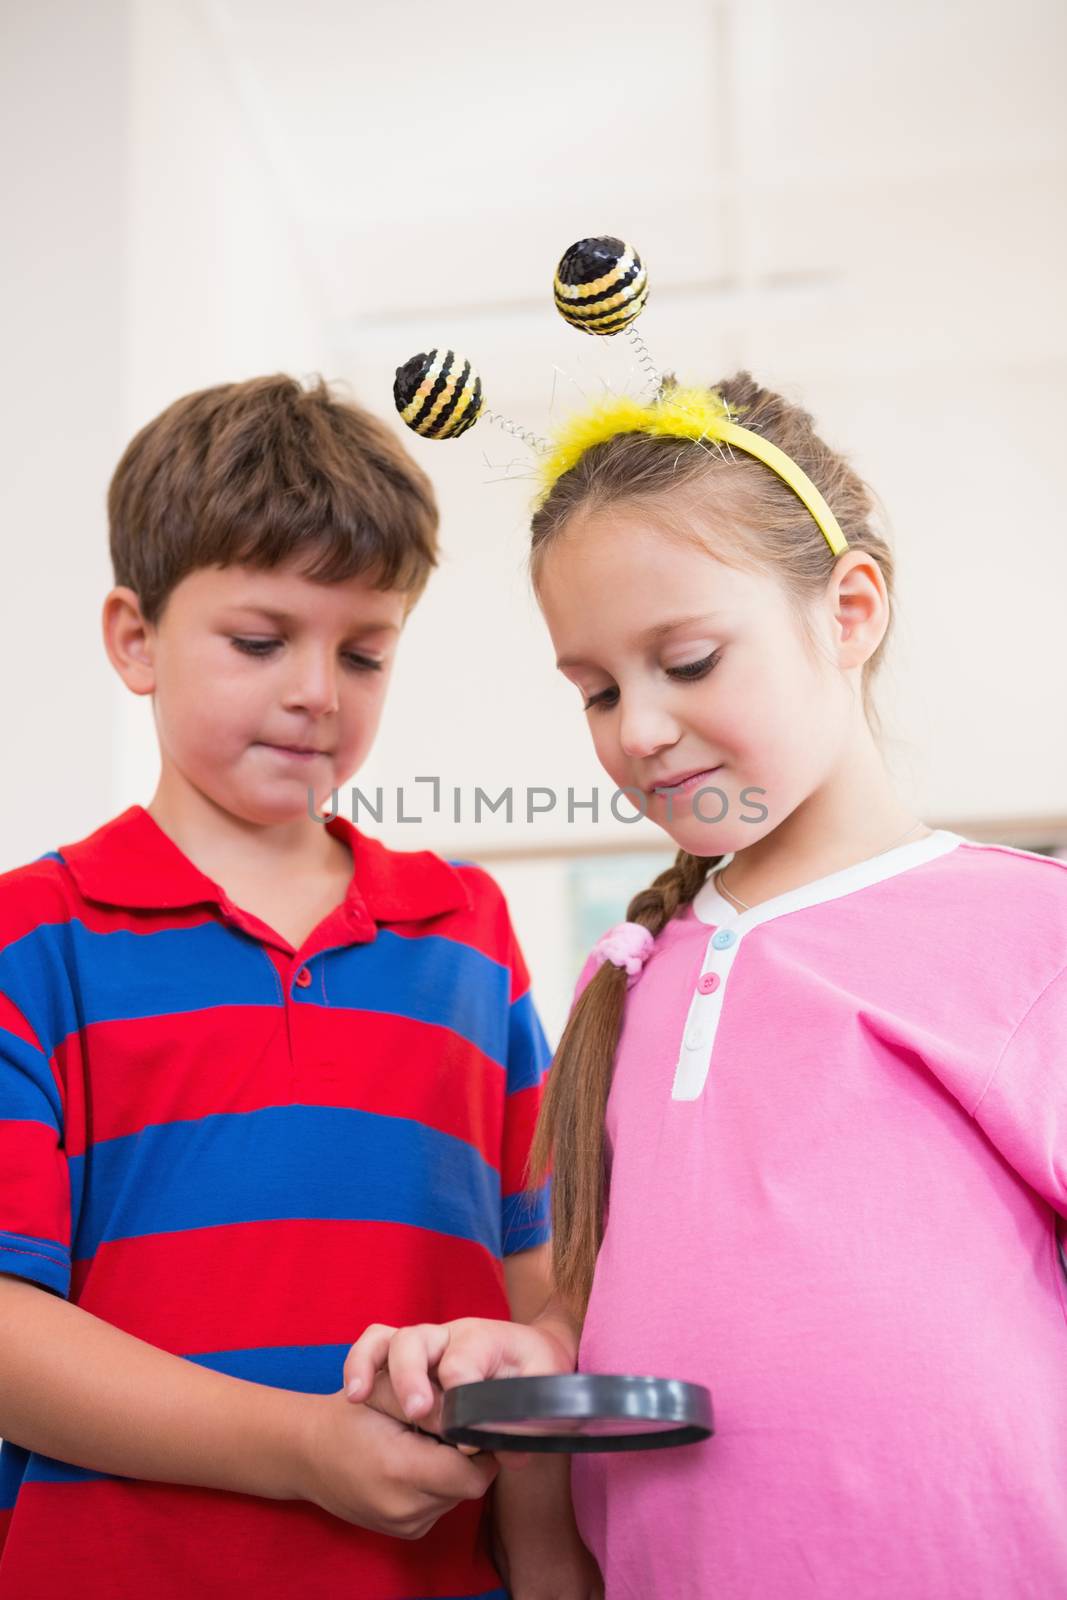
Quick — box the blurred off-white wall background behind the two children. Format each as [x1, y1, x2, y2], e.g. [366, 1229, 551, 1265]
[0, 0, 1067, 1034]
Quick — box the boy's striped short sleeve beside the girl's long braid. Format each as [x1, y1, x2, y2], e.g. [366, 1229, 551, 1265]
[501, 930, 552, 1256]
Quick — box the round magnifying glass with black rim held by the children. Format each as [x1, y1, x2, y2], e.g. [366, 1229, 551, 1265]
[442, 1373, 715, 1454]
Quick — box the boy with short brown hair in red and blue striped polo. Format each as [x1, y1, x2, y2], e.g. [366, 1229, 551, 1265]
[0, 378, 598, 1600]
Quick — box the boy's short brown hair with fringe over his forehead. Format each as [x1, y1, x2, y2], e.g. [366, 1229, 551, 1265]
[107, 373, 438, 622]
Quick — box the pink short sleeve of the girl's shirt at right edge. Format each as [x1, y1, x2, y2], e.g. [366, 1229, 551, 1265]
[974, 968, 1067, 1216]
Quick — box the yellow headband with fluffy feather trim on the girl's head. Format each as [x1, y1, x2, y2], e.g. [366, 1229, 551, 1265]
[539, 389, 848, 555]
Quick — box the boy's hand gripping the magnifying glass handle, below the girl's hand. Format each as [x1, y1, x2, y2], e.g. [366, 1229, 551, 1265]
[301, 1381, 498, 1539]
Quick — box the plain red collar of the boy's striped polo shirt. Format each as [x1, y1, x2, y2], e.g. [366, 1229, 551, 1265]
[59, 805, 470, 923]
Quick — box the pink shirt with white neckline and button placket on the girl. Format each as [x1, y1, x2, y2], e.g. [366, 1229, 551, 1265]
[573, 830, 1067, 1600]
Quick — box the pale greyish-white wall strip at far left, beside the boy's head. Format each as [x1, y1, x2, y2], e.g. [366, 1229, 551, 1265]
[0, 0, 130, 867]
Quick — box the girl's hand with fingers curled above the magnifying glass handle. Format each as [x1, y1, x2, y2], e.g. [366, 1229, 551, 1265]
[344, 1317, 574, 1429]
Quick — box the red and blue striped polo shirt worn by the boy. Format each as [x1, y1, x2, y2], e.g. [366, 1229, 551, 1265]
[0, 805, 549, 1600]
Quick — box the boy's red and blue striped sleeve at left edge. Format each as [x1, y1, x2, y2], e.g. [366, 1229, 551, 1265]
[0, 946, 70, 1296]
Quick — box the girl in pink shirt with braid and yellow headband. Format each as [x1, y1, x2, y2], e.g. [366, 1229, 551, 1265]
[346, 374, 1067, 1600]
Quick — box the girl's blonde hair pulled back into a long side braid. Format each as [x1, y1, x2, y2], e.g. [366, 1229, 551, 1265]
[530, 373, 894, 1314]
